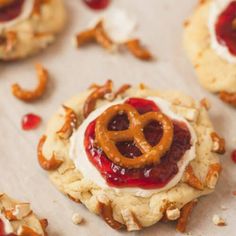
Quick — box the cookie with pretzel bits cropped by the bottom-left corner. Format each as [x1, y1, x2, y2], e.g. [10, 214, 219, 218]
[0, 193, 48, 236]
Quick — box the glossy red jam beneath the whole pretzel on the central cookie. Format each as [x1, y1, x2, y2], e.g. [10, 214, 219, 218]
[84, 98, 191, 189]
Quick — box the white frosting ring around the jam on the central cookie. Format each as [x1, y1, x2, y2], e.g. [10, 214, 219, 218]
[70, 97, 197, 197]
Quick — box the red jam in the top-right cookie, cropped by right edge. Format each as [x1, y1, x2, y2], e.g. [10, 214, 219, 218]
[215, 1, 236, 56]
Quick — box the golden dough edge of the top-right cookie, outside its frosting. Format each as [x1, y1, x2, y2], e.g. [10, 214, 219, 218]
[184, 0, 236, 105]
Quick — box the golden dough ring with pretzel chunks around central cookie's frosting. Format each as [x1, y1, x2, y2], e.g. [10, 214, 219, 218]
[38, 82, 224, 231]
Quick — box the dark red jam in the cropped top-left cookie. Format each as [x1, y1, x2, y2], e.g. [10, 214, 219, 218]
[0, 0, 25, 22]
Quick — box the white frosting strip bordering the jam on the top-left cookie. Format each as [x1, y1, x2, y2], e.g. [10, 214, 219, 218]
[0, 0, 35, 31]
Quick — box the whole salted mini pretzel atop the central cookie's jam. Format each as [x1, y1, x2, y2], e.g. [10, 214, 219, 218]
[95, 104, 173, 168]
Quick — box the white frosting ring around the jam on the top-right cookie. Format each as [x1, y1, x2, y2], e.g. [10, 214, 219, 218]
[208, 0, 236, 63]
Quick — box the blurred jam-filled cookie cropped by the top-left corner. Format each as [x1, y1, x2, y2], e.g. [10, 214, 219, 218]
[0, 0, 66, 61]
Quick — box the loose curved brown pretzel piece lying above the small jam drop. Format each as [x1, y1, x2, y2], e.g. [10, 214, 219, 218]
[12, 64, 48, 102]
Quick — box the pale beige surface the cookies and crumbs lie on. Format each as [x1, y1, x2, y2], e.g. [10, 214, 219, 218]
[0, 0, 236, 236]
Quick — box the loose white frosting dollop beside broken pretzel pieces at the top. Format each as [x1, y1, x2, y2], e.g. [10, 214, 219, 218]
[91, 7, 136, 43]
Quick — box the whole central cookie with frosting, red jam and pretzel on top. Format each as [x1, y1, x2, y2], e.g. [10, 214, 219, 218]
[38, 81, 224, 231]
